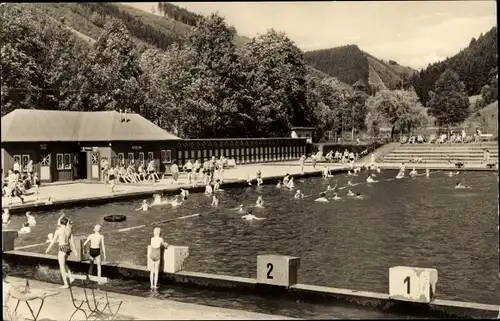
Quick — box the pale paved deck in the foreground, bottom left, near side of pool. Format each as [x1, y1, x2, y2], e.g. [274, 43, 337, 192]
[4, 276, 292, 321]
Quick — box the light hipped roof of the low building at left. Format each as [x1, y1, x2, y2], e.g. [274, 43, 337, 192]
[2, 109, 180, 142]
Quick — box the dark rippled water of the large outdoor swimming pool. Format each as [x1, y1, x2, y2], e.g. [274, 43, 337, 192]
[9, 170, 498, 304]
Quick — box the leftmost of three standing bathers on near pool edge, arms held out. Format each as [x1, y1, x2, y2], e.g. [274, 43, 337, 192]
[45, 217, 77, 289]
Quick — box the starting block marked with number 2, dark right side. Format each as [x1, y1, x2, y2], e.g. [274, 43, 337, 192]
[257, 255, 300, 287]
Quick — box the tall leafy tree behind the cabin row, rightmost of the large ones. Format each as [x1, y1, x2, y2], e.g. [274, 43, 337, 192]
[241, 30, 311, 137]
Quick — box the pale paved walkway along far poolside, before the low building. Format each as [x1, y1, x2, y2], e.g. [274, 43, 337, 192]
[2, 161, 348, 211]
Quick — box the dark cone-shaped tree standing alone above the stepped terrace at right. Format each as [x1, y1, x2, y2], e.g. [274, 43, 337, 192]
[427, 69, 470, 126]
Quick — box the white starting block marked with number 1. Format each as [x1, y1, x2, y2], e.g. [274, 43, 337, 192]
[389, 266, 438, 303]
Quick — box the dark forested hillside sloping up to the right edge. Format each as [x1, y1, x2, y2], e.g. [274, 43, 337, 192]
[411, 27, 498, 104]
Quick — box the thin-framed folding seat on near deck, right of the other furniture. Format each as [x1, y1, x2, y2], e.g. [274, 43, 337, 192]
[69, 274, 123, 321]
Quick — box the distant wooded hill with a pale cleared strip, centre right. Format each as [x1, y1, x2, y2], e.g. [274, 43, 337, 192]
[304, 45, 415, 90]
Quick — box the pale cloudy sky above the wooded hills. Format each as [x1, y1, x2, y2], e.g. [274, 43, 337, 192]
[126, 0, 497, 69]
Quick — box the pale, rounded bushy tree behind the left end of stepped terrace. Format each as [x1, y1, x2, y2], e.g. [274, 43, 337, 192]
[366, 90, 430, 137]
